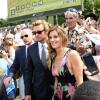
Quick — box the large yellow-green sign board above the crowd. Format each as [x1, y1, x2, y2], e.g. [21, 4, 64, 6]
[8, 0, 81, 18]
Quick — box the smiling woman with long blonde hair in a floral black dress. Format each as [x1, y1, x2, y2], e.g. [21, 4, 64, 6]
[48, 26, 83, 100]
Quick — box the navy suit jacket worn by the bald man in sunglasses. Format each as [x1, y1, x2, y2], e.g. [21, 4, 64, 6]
[10, 45, 26, 77]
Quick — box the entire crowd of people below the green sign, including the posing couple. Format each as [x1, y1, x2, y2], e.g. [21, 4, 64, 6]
[0, 8, 100, 100]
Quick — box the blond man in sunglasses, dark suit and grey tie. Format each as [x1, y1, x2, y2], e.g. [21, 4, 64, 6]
[25, 20, 53, 100]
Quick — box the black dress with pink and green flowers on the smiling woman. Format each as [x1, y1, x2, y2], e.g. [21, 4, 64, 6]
[52, 50, 75, 100]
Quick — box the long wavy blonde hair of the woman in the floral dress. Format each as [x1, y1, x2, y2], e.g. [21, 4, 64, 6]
[48, 25, 68, 68]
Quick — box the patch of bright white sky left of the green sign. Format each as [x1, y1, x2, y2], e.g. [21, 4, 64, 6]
[0, 0, 7, 19]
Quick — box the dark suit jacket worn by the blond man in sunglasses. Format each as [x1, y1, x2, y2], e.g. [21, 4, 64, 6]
[25, 43, 53, 98]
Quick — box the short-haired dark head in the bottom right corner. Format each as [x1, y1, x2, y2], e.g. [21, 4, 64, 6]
[72, 80, 100, 100]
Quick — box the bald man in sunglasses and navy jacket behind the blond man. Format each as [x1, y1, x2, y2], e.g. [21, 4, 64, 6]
[4, 28, 33, 100]
